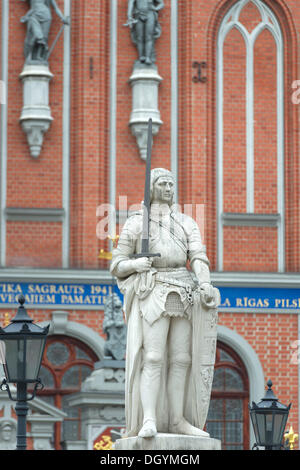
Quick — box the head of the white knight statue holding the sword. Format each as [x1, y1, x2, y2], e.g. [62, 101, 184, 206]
[150, 168, 175, 206]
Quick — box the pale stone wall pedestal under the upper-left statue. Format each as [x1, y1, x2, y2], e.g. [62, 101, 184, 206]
[20, 64, 53, 158]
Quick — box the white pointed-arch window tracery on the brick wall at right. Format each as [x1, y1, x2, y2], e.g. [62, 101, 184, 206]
[217, 0, 285, 272]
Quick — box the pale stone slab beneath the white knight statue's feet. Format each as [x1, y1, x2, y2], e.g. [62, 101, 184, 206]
[115, 433, 221, 450]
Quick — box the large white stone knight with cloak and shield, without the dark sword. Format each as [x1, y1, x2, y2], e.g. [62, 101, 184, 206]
[111, 168, 220, 438]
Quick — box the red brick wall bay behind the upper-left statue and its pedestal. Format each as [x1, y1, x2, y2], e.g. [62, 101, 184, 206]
[6, 0, 64, 267]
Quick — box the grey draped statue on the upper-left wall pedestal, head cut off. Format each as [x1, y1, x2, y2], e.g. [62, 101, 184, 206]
[21, 0, 69, 64]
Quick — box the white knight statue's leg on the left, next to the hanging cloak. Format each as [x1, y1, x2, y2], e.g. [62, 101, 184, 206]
[139, 317, 170, 437]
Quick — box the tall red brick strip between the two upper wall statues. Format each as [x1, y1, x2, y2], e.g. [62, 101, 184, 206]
[70, 0, 110, 268]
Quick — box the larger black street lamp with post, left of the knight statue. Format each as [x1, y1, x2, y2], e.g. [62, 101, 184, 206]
[0, 295, 49, 450]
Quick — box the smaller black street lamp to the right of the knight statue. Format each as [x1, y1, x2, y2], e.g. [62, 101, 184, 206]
[249, 380, 291, 450]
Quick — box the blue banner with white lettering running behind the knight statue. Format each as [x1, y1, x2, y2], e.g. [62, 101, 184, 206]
[0, 282, 300, 313]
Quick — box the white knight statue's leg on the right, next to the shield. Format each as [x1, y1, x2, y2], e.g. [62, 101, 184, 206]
[168, 317, 209, 437]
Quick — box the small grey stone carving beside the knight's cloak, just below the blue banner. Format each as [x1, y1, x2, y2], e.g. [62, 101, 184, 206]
[103, 294, 127, 360]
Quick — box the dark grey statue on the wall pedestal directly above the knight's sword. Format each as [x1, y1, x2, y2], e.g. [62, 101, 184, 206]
[126, 0, 164, 65]
